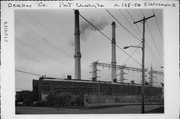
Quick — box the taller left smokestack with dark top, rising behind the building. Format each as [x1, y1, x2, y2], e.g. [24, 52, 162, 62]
[74, 10, 81, 80]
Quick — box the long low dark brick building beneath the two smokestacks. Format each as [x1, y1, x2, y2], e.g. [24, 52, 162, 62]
[33, 78, 163, 106]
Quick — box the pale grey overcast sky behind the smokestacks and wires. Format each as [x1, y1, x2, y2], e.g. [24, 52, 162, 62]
[15, 9, 163, 90]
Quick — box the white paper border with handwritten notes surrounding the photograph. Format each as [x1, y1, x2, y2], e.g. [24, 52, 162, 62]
[1, 0, 180, 119]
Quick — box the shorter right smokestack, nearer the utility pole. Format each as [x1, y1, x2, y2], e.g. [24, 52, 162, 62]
[111, 22, 117, 82]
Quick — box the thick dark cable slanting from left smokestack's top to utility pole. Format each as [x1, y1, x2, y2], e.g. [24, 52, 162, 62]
[79, 10, 141, 66]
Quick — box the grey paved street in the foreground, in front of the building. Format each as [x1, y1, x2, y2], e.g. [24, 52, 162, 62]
[16, 105, 163, 114]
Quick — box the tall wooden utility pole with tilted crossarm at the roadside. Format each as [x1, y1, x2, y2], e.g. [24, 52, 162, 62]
[134, 15, 155, 113]
